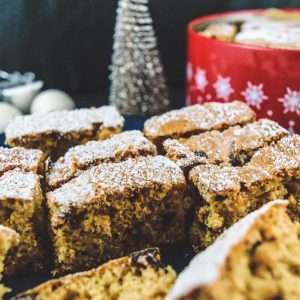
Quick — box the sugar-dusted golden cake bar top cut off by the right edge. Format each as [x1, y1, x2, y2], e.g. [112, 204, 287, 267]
[248, 134, 300, 172]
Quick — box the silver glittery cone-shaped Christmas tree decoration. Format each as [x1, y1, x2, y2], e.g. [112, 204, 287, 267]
[109, 0, 169, 115]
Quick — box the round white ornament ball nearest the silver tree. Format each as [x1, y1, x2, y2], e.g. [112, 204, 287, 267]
[30, 90, 75, 114]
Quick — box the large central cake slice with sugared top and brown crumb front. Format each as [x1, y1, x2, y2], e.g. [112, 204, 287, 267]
[47, 156, 191, 273]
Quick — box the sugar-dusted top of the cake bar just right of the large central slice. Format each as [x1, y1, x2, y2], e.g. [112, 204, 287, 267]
[189, 164, 273, 193]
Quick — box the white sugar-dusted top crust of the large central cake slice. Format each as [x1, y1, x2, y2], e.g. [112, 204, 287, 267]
[47, 156, 185, 215]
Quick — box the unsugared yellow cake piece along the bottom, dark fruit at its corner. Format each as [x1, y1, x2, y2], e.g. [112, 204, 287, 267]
[14, 249, 176, 300]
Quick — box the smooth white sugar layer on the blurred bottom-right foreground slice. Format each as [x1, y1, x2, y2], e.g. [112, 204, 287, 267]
[167, 200, 288, 300]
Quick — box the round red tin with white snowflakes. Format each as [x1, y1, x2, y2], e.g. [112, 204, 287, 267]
[186, 9, 300, 133]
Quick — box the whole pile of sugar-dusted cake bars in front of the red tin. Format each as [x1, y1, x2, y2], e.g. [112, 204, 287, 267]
[0, 101, 300, 299]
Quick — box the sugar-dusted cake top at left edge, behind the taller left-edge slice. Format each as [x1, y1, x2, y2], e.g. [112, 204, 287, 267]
[0, 147, 44, 175]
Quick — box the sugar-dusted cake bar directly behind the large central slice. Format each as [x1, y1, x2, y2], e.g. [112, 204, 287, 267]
[47, 130, 157, 189]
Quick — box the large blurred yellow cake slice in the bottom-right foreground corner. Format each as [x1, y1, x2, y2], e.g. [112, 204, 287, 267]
[166, 200, 300, 300]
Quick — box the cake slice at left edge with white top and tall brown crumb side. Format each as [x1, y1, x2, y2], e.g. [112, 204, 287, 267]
[0, 170, 45, 275]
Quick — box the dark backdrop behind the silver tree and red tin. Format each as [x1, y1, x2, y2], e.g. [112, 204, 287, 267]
[0, 0, 300, 107]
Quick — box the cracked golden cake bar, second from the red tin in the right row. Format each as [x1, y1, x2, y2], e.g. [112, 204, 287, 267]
[163, 119, 288, 170]
